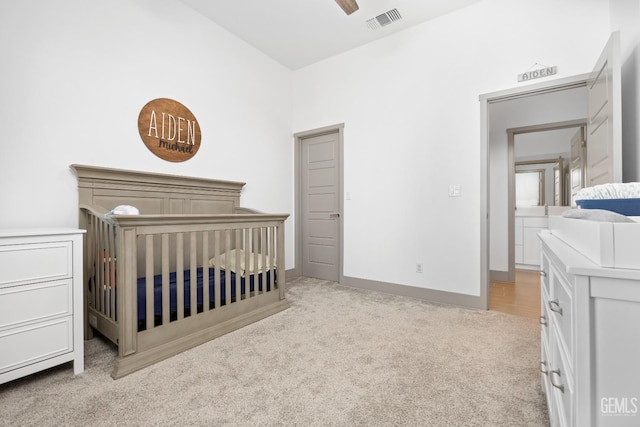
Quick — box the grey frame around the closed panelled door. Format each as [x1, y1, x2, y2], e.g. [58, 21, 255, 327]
[293, 123, 344, 282]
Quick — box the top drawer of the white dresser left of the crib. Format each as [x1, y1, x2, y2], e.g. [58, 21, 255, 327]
[0, 241, 73, 287]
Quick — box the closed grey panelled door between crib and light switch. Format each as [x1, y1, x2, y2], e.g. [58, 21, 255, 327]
[301, 132, 341, 282]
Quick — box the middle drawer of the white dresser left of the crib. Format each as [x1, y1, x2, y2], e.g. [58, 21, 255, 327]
[0, 279, 73, 331]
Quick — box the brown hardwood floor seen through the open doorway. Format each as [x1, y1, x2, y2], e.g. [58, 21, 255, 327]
[489, 270, 540, 319]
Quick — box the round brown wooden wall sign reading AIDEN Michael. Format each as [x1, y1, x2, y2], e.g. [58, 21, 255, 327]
[138, 98, 202, 162]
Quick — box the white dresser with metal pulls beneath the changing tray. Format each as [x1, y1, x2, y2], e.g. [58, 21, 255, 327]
[540, 232, 640, 427]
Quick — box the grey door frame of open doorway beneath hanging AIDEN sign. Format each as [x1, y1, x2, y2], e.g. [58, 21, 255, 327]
[479, 73, 590, 309]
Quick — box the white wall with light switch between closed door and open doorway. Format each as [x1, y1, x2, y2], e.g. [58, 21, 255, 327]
[293, 0, 609, 295]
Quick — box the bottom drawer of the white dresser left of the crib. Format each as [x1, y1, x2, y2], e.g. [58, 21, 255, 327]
[0, 316, 73, 374]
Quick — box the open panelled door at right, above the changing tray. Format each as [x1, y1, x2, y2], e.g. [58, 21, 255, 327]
[586, 32, 622, 187]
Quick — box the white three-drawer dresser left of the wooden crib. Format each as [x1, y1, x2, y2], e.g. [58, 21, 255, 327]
[0, 228, 84, 383]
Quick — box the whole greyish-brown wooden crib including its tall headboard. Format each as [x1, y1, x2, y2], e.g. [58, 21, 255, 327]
[71, 165, 289, 378]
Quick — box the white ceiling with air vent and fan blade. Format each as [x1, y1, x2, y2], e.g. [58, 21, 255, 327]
[181, 0, 480, 70]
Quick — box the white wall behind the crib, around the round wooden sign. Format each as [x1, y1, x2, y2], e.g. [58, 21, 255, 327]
[0, 0, 293, 267]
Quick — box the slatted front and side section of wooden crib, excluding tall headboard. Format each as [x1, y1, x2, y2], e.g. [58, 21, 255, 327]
[85, 209, 288, 378]
